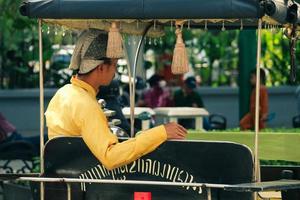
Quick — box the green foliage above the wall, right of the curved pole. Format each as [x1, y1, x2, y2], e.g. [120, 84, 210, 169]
[146, 28, 300, 86]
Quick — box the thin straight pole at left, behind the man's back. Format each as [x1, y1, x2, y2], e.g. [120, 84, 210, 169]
[38, 19, 44, 200]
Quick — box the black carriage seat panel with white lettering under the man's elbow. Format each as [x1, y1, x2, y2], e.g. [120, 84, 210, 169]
[36, 137, 253, 200]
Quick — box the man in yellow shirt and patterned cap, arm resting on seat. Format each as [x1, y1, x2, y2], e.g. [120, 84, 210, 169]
[45, 30, 186, 169]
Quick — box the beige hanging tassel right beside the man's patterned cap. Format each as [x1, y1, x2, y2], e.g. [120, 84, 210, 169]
[106, 22, 124, 58]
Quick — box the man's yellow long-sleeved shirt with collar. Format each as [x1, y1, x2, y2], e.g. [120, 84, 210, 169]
[45, 77, 167, 169]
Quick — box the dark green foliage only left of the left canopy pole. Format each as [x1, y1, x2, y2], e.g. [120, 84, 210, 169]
[0, 0, 37, 88]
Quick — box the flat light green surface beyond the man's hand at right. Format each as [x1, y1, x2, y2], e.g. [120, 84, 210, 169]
[187, 128, 300, 166]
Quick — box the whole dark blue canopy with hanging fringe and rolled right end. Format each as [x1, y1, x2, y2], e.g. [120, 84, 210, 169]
[20, 0, 300, 28]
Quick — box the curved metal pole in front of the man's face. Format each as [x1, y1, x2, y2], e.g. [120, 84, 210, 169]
[129, 23, 153, 137]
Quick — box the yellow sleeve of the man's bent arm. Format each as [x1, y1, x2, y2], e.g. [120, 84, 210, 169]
[78, 103, 167, 169]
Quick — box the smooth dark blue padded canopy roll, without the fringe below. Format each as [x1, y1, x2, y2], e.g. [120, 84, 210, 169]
[20, 0, 264, 19]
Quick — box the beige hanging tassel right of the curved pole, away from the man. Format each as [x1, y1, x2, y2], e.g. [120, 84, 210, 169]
[171, 22, 189, 74]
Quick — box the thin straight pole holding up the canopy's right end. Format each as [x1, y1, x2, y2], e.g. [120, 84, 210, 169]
[254, 19, 262, 182]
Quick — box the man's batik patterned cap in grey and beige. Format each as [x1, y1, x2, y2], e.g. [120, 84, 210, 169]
[69, 29, 108, 74]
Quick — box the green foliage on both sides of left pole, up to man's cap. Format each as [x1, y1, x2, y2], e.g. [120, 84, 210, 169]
[0, 0, 73, 89]
